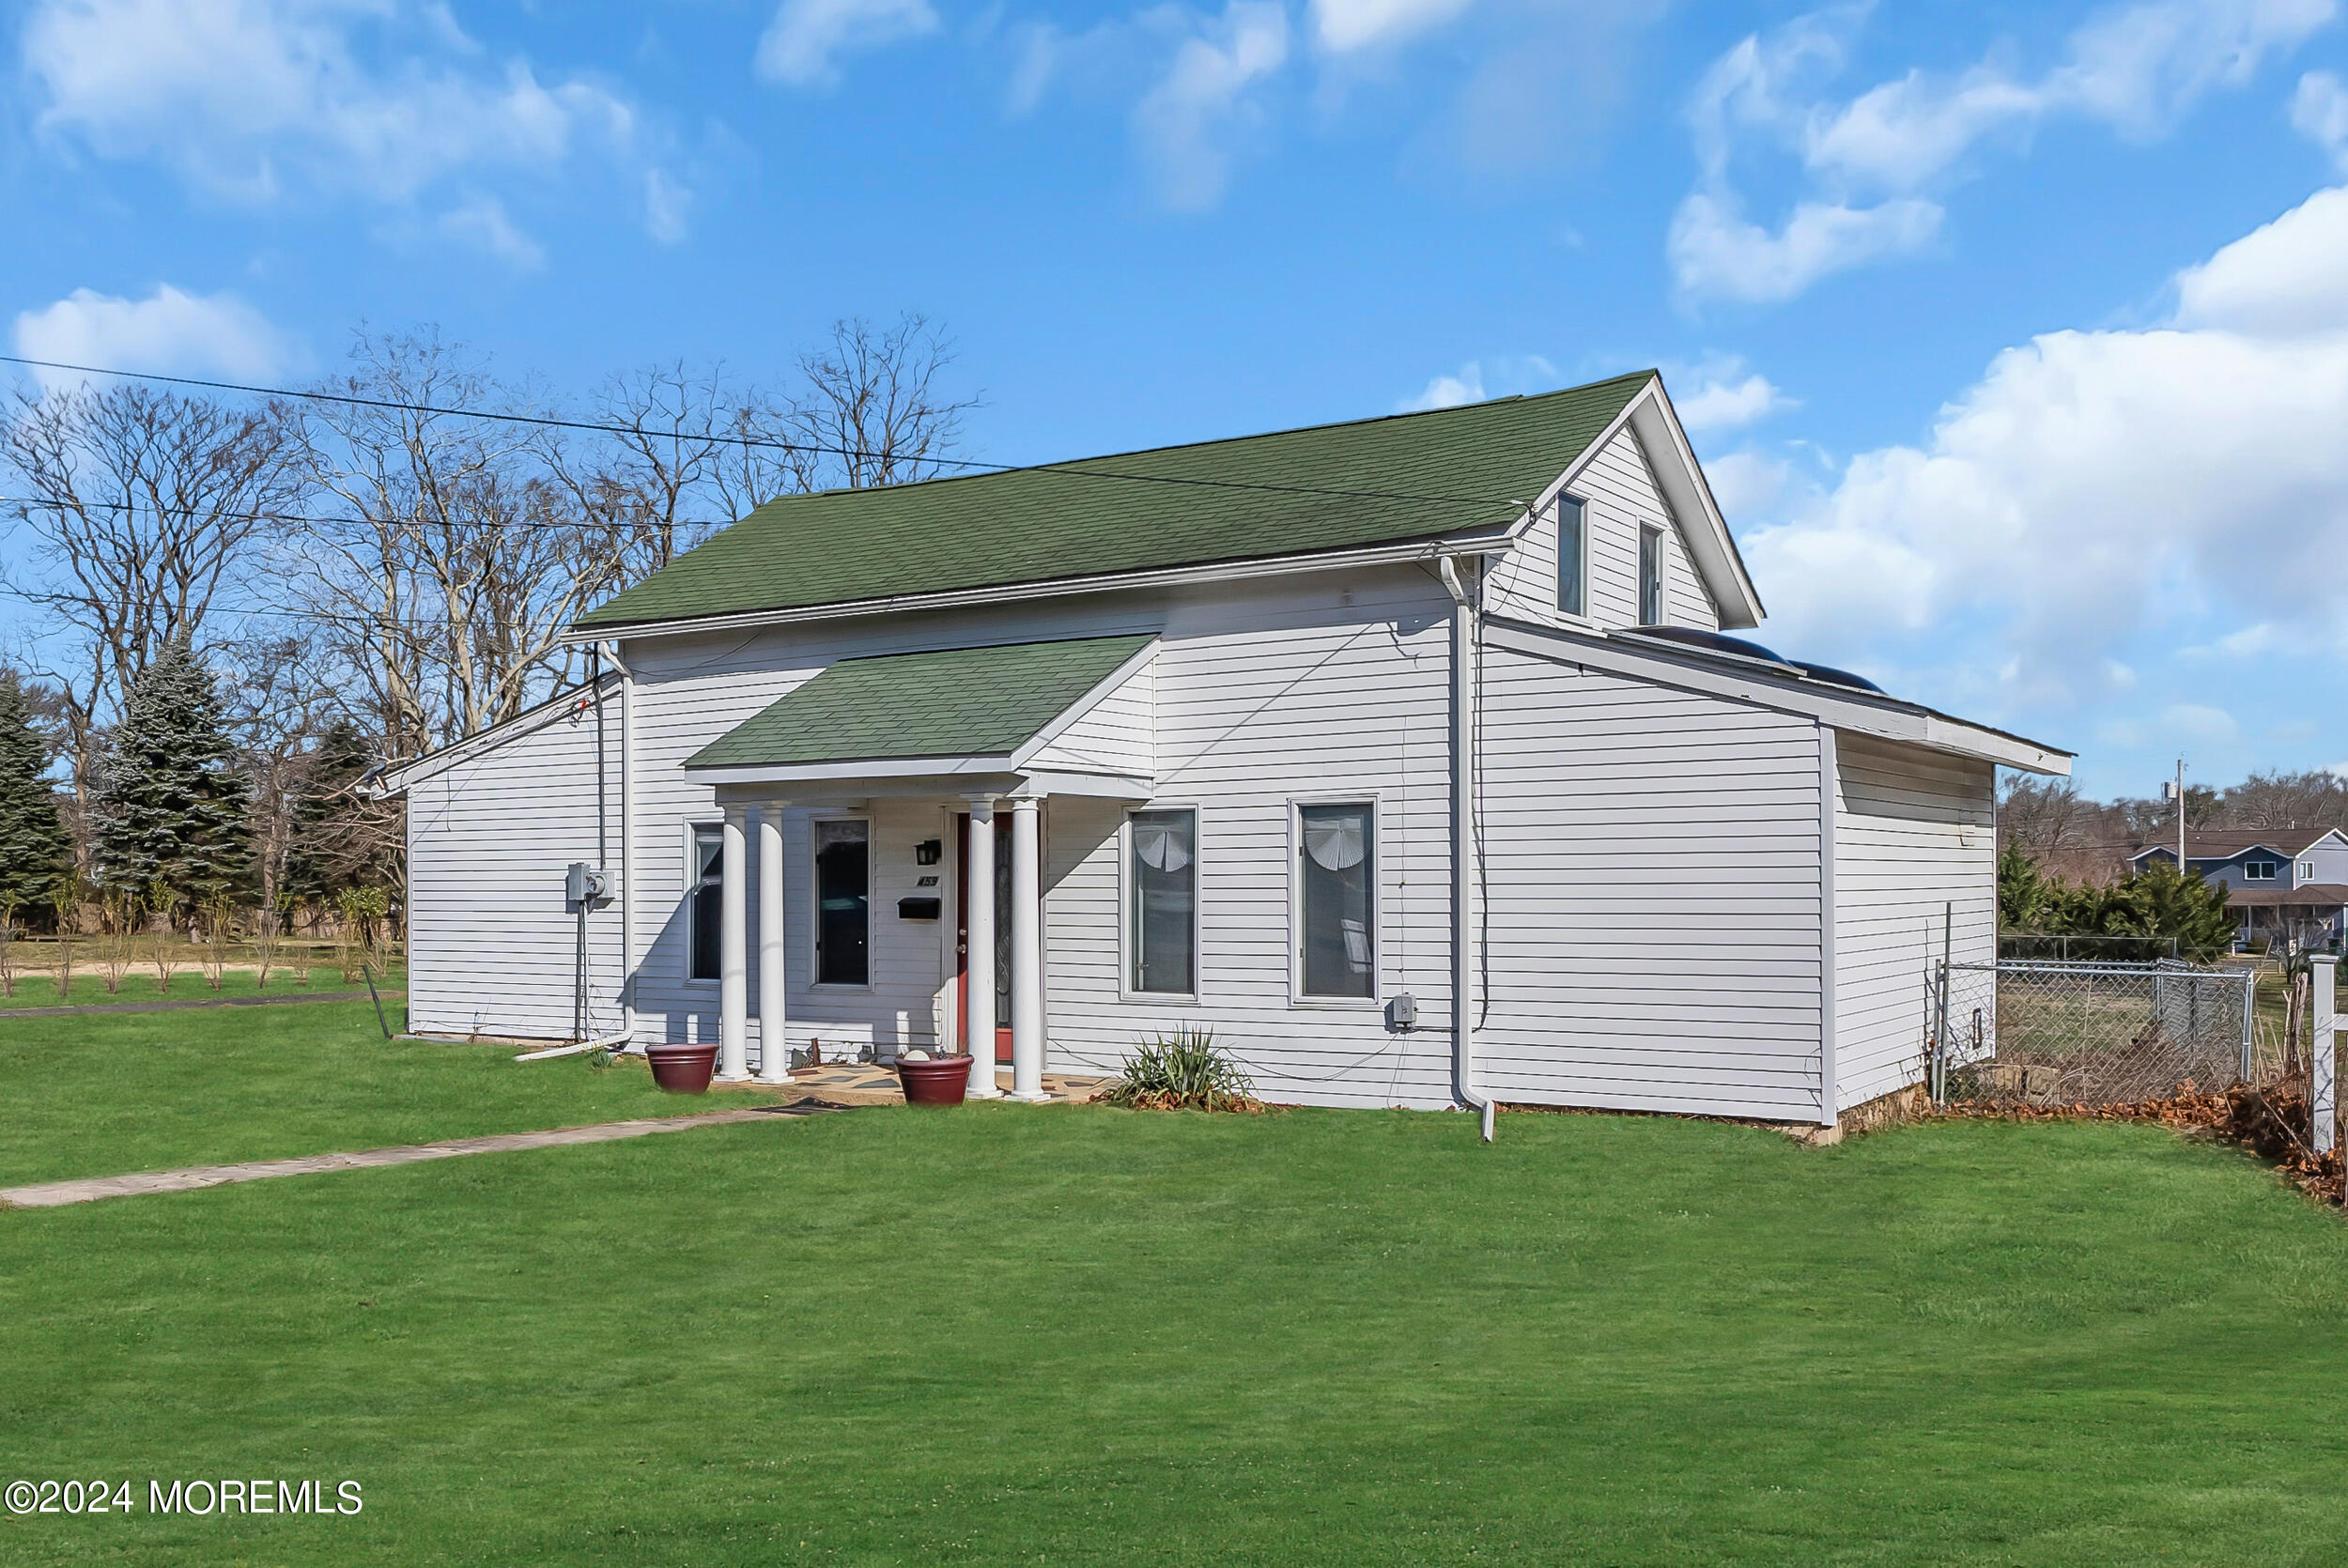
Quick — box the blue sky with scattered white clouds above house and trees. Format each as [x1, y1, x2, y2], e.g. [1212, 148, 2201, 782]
[0, 0, 2348, 793]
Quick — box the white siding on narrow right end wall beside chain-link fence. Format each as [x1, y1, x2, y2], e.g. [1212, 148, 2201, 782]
[1834, 732, 1999, 1111]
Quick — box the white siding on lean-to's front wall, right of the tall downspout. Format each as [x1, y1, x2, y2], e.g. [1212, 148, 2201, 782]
[1477, 646, 1822, 1120]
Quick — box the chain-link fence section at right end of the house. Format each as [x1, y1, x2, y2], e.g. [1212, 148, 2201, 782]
[1925, 958, 2259, 1106]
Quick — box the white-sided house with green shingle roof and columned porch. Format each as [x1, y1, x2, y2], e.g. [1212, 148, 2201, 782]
[388, 374, 2069, 1141]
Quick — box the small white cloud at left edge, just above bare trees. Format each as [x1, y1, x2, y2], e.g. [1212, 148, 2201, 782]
[14, 284, 299, 399]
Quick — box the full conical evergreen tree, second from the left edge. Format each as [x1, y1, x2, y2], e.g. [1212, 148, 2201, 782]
[92, 638, 252, 904]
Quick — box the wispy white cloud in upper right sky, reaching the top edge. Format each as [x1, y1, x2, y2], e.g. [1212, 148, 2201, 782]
[1667, 0, 2348, 303]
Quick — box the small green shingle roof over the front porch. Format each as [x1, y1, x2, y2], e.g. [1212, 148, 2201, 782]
[686, 634, 1151, 768]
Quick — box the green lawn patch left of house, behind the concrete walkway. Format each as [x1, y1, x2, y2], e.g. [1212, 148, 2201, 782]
[0, 1000, 789, 1186]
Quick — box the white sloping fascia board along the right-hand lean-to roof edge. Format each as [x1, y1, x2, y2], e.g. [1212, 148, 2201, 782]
[1484, 618, 2071, 777]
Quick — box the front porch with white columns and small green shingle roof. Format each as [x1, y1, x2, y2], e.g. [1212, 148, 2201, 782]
[686, 637, 1155, 1103]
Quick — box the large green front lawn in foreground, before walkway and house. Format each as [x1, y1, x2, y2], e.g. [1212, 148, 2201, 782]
[0, 1061, 2348, 1568]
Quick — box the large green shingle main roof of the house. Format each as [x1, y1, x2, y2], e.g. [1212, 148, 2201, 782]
[578, 371, 1653, 629]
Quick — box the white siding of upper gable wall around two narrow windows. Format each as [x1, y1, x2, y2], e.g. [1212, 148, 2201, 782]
[1487, 430, 1722, 632]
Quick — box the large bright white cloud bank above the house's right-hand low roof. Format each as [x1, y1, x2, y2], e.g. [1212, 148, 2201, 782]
[1745, 179, 2348, 704]
